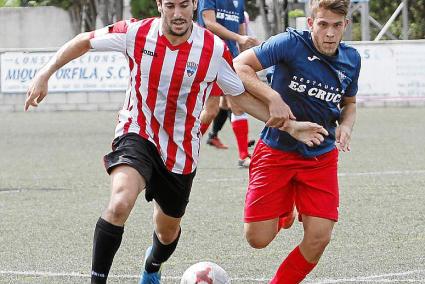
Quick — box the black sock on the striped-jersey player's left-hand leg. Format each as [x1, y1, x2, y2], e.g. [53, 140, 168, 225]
[91, 218, 124, 284]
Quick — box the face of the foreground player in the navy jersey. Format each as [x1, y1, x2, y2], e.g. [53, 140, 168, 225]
[307, 8, 348, 56]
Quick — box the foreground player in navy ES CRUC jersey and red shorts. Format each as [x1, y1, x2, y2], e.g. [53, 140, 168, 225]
[234, 0, 360, 283]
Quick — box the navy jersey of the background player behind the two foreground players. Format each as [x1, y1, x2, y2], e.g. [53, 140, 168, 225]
[198, 0, 245, 57]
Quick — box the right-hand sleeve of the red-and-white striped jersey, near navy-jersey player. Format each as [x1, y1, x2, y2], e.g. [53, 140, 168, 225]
[217, 46, 245, 96]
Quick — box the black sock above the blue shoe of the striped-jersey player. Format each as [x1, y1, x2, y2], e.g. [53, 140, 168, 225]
[145, 228, 182, 273]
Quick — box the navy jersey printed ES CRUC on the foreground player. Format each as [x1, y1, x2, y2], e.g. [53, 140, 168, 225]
[254, 29, 361, 157]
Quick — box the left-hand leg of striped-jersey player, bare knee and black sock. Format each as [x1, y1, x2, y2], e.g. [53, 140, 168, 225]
[91, 165, 145, 283]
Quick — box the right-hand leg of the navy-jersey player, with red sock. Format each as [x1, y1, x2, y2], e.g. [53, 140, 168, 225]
[270, 214, 335, 284]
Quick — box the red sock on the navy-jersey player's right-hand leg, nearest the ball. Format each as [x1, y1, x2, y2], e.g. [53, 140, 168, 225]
[270, 246, 316, 284]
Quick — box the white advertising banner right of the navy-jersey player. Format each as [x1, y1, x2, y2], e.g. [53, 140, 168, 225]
[352, 41, 425, 100]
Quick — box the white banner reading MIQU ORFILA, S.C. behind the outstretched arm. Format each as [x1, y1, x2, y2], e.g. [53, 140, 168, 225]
[0, 52, 129, 93]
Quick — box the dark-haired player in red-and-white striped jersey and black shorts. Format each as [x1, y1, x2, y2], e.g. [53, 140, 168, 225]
[25, 0, 326, 283]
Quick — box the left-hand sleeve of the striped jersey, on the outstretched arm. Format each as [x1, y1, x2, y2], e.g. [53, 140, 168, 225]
[90, 20, 132, 53]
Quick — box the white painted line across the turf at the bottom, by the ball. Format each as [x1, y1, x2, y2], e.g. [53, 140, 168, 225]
[0, 270, 425, 284]
